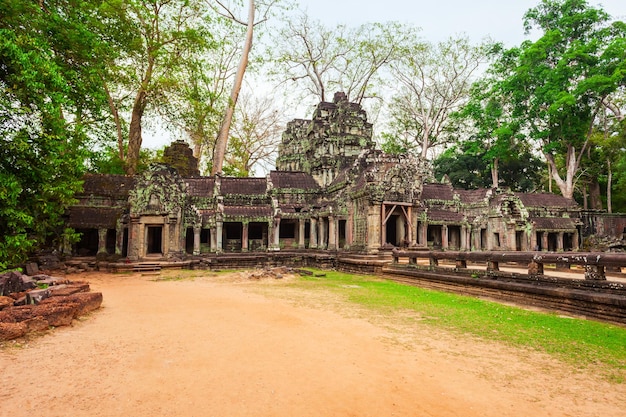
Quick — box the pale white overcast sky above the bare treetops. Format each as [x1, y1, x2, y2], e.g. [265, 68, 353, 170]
[298, 0, 626, 47]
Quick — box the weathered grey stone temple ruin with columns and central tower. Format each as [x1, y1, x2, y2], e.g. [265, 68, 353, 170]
[66, 93, 626, 261]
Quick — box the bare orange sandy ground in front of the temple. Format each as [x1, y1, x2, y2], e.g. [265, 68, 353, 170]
[0, 273, 626, 417]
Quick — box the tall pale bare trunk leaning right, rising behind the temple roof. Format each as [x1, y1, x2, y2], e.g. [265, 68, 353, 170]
[211, 0, 254, 175]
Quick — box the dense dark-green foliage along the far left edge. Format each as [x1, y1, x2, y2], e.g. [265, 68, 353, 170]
[0, 0, 116, 269]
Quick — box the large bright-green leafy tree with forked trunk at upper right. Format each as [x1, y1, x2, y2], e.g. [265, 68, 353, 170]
[490, 0, 626, 198]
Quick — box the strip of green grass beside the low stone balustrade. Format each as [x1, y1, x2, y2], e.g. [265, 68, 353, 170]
[290, 271, 626, 383]
